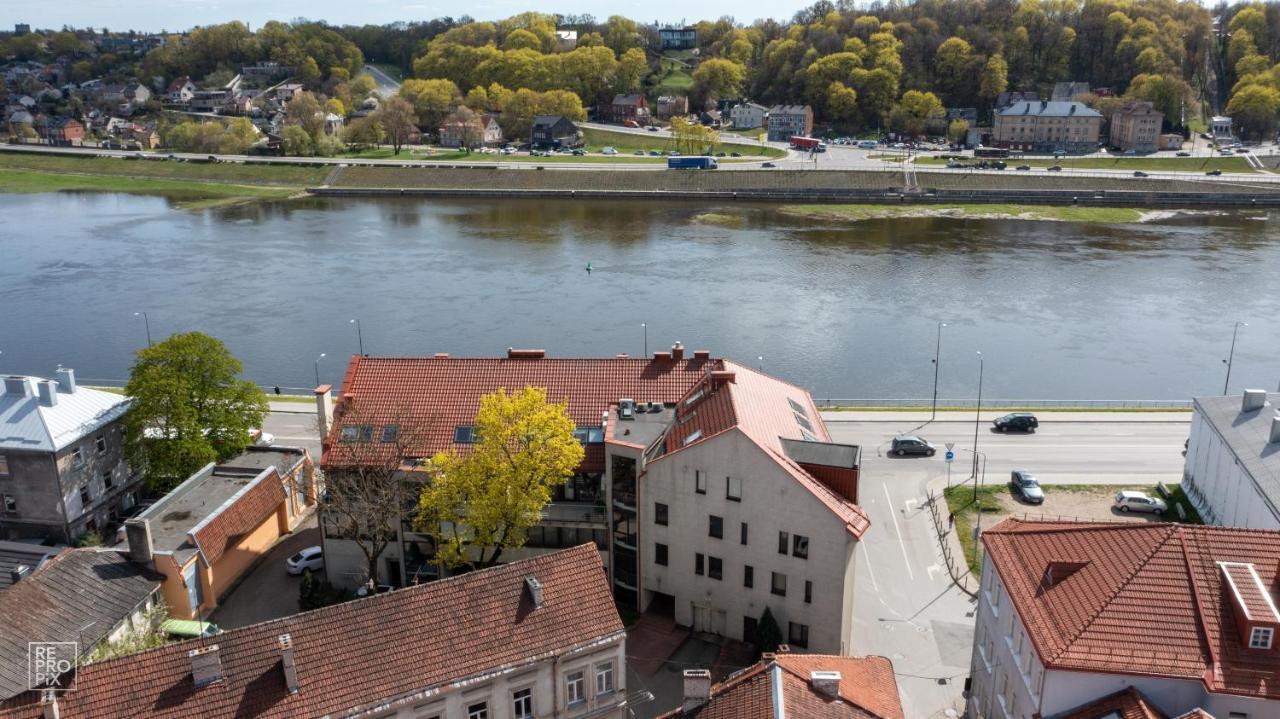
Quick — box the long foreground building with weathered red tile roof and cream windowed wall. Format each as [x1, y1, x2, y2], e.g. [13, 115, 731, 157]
[0, 546, 627, 719]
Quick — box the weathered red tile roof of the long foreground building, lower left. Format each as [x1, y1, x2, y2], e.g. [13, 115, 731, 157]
[0, 545, 622, 719]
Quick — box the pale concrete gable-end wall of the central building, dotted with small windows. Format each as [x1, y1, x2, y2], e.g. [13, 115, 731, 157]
[637, 430, 856, 654]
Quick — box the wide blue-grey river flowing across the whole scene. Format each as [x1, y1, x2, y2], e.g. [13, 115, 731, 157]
[0, 193, 1280, 399]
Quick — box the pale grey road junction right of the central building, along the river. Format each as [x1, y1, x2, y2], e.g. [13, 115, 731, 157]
[823, 412, 1190, 719]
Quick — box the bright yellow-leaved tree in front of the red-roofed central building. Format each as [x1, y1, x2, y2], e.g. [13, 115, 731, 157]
[413, 386, 584, 567]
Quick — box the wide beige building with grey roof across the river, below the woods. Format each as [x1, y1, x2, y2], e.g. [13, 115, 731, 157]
[993, 100, 1102, 152]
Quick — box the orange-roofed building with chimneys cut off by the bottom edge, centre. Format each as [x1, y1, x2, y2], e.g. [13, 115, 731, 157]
[658, 651, 904, 719]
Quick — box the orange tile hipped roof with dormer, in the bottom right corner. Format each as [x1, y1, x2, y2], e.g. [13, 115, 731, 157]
[983, 519, 1280, 699]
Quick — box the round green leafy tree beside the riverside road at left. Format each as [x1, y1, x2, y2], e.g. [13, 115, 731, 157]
[124, 333, 268, 493]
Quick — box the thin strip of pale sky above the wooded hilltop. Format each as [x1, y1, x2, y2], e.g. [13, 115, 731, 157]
[0, 0, 812, 31]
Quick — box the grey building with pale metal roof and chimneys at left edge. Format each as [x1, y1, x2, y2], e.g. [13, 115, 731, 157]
[0, 368, 142, 544]
